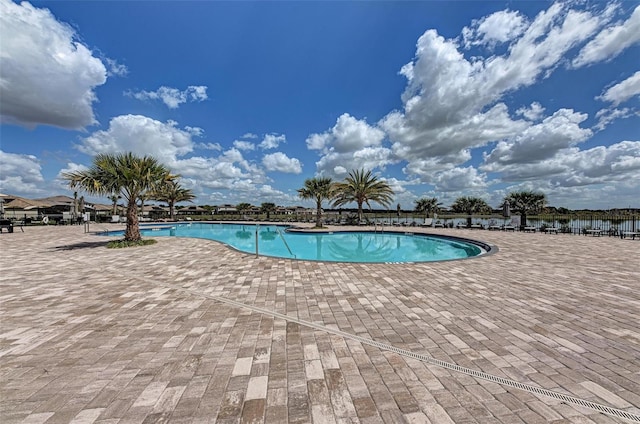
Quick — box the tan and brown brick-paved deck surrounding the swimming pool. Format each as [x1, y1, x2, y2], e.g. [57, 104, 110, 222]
[0, 224, 640, 424]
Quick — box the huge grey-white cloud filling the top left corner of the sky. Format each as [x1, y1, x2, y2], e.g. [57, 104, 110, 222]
[0, 0, 107, 129]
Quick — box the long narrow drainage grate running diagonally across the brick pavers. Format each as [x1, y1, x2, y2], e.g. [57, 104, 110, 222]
[170, 284, 640, 423]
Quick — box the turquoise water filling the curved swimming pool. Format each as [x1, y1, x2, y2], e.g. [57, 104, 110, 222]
[115, 223, 486, 262]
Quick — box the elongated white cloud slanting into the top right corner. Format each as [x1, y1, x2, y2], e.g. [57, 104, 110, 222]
[572, 6, 640, 68]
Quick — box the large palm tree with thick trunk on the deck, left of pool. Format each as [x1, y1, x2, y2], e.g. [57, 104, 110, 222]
[62, 153, 172, 241]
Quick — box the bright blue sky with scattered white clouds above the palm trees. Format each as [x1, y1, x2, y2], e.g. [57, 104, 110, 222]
[0, 0, 640, 209]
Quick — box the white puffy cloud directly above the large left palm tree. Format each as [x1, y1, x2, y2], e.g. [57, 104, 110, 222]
[77, 115, 194, 166]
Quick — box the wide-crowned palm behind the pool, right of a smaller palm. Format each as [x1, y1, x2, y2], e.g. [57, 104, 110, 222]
[333, 169, 393, 221]
